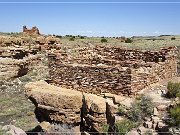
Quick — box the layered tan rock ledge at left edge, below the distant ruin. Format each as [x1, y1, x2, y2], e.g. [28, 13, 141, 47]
[0, 36, 40, 79]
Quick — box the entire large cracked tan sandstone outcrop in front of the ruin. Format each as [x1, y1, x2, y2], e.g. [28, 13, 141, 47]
[25, 81, 129, 135]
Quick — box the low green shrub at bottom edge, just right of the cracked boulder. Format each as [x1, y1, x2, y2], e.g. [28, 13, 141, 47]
[115, 119, 137, 135]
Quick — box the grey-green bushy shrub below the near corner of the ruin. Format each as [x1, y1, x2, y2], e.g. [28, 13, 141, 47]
[127, 95, 154, 121]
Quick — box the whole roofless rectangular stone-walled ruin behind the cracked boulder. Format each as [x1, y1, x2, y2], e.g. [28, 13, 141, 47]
[49, 46, 177, 96]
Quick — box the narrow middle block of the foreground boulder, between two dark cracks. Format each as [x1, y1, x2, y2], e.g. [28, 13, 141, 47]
[82, 93, 107, 132]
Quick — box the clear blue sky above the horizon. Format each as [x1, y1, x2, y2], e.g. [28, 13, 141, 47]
[0, 0, 180, 36]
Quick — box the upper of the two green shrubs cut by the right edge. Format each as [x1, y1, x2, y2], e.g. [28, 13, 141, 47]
[166, 82, 180, 98]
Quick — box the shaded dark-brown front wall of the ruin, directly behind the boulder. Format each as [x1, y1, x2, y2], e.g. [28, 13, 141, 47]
[49, 55, 131, 94]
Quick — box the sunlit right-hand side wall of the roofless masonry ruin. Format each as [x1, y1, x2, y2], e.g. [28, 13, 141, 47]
[131, 54, 177, 93]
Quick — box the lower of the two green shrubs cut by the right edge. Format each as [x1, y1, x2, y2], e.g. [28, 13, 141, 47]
[170, 104, 180, 126]
